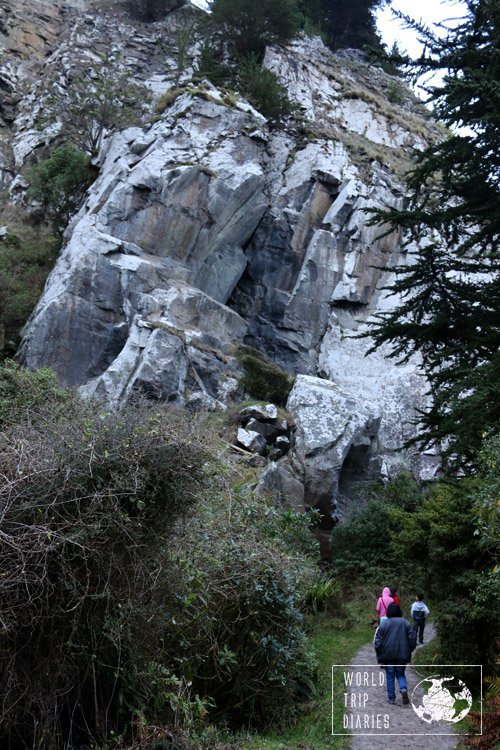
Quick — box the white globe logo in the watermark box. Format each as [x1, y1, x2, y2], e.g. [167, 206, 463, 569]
[411, 677, 472, 724]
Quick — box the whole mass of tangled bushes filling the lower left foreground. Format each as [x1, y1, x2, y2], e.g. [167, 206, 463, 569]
[0, 364, 318, 750]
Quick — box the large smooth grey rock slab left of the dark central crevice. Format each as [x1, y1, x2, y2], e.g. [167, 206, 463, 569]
[21, 95, 266, 403]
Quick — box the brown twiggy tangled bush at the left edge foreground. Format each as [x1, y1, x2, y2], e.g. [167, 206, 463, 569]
[0, 402, 217, 750]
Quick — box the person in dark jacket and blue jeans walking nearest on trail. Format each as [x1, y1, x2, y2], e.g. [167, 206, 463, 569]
[373, 602, 417, 704]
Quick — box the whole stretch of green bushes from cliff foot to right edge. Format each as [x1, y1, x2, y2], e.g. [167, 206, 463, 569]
[332, 446, 500, 673]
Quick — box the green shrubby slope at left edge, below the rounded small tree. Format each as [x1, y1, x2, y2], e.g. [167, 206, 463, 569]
[0, 226, 61, 356]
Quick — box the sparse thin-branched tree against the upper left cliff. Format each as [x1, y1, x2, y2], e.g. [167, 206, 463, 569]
[39, 58, 150, 157]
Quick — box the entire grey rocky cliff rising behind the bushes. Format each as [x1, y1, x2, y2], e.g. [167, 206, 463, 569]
[0, 0, 442, 544]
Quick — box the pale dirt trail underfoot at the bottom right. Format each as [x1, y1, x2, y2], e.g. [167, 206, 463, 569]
[347, 623, 459, 750]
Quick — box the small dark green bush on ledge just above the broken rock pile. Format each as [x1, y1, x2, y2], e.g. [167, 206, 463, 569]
[236, 346, 294, 406]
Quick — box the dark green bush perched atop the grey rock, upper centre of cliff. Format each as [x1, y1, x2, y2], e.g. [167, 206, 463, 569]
[238, 54, 291, 120]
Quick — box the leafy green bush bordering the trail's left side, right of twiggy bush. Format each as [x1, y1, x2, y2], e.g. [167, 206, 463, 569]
[165, 491, 317, 725]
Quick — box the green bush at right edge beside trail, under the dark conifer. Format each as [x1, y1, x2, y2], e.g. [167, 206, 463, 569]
[391, 436, 500, 669]
